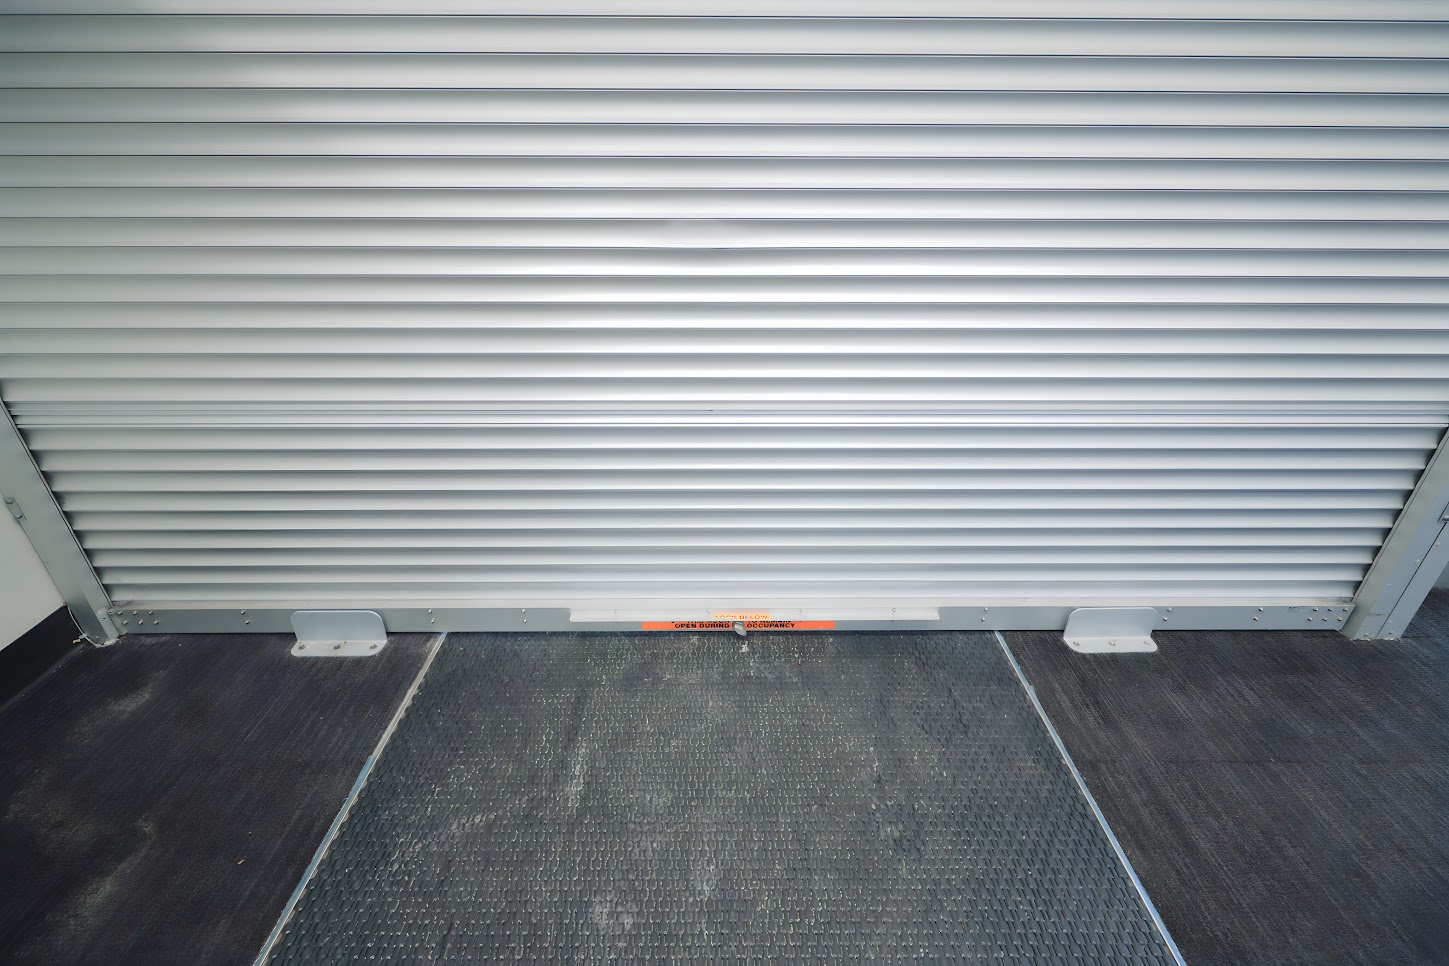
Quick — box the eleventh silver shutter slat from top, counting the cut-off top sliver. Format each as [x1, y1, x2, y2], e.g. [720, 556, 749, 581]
[3, 301, 1445, 330]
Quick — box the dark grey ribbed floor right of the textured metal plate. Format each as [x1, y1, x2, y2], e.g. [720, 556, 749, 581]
[1006, 591, 1449, 966]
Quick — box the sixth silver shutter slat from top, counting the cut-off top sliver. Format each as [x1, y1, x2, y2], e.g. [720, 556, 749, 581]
[0, 155, 1449, 189]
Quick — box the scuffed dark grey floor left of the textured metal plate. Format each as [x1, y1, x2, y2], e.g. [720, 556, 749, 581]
[0, 634, 430, 963]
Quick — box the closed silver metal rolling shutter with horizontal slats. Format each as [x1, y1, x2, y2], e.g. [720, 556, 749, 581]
[0, 0, 1449, 631]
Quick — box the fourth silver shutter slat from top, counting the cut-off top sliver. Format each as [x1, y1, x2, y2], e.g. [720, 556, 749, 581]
[0, 87, 1449, 127]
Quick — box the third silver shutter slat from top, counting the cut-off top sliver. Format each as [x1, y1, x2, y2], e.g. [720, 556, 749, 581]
[0, 51, 1449, 94]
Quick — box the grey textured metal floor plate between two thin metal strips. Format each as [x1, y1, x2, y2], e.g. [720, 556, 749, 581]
[272, 633, 1171, 963]
